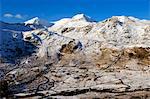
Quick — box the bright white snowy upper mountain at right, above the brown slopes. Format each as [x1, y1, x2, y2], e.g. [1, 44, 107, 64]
[49, 15, 150, 47]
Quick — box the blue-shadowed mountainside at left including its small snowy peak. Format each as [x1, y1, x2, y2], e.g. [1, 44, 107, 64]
[0, 17, 52, 61]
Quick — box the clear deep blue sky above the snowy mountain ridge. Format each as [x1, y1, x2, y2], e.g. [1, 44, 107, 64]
[0, 0, 150, 22]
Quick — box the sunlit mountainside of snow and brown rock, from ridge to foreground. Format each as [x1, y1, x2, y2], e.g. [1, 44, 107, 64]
[0, 14, 150, 98]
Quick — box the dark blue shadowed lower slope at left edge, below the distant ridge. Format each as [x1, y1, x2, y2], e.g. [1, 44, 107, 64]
[0, 30, 37, 63]
